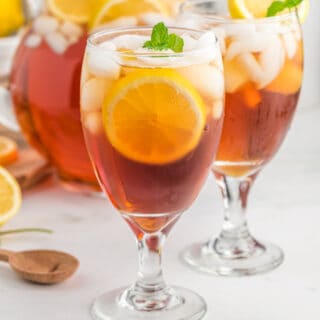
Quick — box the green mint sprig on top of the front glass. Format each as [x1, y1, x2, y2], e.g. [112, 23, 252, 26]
[143, 22, 184, 52]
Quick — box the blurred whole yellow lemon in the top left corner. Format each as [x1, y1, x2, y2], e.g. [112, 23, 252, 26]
[0, 0, 25, 37]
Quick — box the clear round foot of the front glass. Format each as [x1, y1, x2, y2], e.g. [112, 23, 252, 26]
[91, 287, 207, 320]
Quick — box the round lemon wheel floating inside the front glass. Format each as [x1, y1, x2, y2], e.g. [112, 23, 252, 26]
[103, 69, 206, 165]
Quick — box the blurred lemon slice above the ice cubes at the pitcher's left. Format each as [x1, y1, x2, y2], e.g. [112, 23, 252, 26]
[47, 0, 92, 24]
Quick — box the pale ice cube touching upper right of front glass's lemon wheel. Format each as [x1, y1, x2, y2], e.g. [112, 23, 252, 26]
[177, 64, 224, 100]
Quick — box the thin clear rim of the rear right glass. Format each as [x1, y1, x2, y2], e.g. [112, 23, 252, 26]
[179, 0, 300, 24]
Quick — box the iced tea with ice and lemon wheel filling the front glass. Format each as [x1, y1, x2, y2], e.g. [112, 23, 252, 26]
[81, 28, 224, 232]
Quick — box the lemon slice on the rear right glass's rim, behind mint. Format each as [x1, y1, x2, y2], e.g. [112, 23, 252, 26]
[228, 0, 310, 23]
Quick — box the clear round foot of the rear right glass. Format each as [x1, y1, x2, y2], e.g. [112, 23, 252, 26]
[182, 244, 284, 276]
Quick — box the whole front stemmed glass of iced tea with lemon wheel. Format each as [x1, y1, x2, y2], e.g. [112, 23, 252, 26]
[81, 24, 224, 320]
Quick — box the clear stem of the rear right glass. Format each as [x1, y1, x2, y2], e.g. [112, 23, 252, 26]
[208, 173, 261, 258]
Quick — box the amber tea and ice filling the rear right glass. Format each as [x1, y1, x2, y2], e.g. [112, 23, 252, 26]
[214, 23, 303, 177]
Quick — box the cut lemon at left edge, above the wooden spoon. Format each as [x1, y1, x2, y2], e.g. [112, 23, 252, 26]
[0, 167, 21, 225]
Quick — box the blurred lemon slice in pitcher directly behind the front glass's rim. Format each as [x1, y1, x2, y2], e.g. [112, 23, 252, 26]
[89, 0, 167, 28]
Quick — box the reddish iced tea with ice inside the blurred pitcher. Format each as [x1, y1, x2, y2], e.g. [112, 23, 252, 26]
[11, 14, 98, 189]
